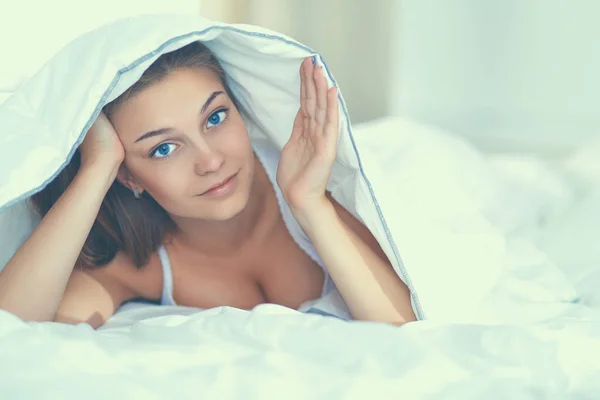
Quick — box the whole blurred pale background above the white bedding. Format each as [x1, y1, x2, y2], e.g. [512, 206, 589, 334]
[0, 0, 600, 153]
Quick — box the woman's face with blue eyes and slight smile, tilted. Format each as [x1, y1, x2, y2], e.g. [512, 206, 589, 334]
[111, 68, 254, 220]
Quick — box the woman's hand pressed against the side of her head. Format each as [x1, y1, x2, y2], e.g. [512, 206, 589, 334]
[79, 112, 125, 167]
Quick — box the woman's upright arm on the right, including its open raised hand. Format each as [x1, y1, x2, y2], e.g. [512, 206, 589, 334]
[277, 57, 415, 324]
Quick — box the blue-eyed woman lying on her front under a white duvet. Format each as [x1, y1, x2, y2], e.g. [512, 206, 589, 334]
[0, 42, 415, 327]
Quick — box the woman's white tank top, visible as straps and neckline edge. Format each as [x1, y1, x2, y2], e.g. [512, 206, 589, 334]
[158, 141, 335, 305]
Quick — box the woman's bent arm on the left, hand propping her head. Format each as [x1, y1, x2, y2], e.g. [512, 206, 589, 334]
[0, 115, 123, 321]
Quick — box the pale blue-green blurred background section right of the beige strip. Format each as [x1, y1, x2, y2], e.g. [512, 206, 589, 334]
[391, 0, 600, 152]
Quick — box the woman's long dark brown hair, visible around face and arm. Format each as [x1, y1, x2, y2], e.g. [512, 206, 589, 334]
[31, 42, 237, 268]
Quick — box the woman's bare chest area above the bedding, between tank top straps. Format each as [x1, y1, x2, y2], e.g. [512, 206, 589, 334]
[167, 221, 325, 309]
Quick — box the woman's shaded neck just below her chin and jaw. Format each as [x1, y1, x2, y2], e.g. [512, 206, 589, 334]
[168, 160, 271, 257]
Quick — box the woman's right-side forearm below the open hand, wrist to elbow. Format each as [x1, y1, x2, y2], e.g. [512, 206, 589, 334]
[296, 196, 416, 325]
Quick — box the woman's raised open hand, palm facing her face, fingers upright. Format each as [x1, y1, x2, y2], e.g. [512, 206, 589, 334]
[277, 57, 339, 214]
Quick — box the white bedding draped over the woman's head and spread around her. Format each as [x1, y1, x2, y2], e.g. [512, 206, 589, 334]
[0, 17, 600, 399]
